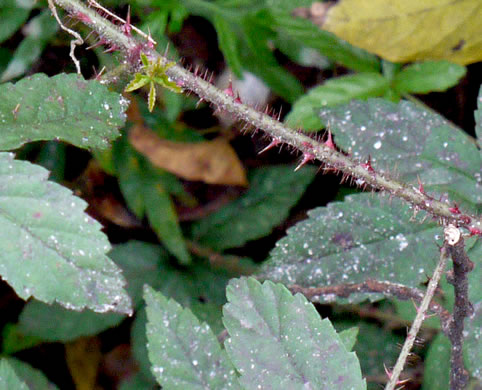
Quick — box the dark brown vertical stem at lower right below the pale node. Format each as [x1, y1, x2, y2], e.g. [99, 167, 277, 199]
[447, 233, 474, 390]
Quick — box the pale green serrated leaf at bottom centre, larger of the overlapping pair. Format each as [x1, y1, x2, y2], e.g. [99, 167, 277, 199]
[223, 278, 366, 390]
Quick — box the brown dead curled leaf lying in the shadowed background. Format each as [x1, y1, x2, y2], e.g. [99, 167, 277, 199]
[129, 124, 248, 186]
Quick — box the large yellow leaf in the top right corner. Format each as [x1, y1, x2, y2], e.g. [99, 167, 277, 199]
[297, 0, 482, 65]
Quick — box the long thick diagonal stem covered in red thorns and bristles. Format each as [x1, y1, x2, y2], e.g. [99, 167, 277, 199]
[53, 0, 482, 232]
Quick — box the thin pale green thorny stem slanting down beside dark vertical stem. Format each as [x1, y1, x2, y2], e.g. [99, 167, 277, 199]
[385, 243, 447, 390]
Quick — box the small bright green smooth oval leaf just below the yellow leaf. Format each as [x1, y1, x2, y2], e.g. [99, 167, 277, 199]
[393, 61, 467, 95]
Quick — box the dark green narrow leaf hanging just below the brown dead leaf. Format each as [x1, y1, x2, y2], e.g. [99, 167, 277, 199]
[114, 137, 191, 264]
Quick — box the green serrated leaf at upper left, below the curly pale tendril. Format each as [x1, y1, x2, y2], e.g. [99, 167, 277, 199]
[0, 74, 128, 150]
